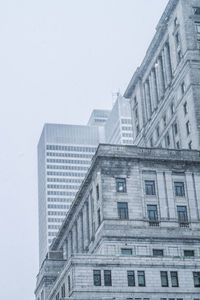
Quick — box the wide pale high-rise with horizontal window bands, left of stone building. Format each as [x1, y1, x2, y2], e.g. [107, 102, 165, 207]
[38, 124, 104, 264]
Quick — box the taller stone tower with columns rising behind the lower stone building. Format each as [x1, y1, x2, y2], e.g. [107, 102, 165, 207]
[124, 0, 200, 149]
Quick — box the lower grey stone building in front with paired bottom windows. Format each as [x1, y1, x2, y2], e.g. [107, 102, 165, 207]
[35, 145, 200, 300]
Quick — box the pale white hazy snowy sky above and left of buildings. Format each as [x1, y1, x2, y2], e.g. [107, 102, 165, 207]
[0, 0, 167, 300]
